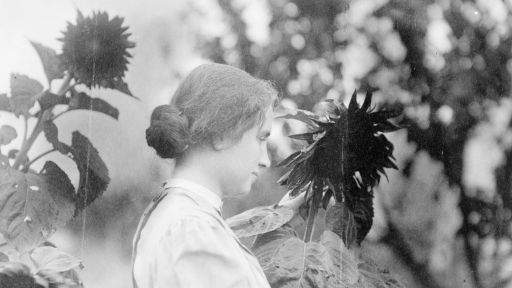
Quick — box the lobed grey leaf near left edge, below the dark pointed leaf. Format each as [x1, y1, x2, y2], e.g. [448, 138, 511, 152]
[10, 74, 43, 118]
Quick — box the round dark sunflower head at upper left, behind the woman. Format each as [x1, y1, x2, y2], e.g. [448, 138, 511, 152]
[59, 11, 135, 88]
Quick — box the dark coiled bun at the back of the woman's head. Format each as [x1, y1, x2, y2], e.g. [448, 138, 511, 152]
[146, 105, 189, 159]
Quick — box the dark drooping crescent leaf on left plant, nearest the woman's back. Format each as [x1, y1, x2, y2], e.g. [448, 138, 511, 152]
[71, 131, 110, 211]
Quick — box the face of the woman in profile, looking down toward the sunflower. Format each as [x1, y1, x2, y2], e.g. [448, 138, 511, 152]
[217, 108, 274, 197]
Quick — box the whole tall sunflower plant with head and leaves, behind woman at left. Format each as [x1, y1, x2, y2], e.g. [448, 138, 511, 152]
[0, 11, 134, 287]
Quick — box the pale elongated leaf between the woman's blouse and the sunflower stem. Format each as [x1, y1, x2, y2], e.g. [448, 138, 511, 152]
[227, 206, 294, 238]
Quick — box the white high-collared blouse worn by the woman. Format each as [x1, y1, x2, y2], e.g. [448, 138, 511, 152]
[132, 179, 270, 288]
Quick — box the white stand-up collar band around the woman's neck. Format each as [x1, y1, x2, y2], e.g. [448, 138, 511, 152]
[162, 178, 222, 213]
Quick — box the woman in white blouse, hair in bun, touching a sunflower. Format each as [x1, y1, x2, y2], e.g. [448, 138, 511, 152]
[133, 64, 303, 288]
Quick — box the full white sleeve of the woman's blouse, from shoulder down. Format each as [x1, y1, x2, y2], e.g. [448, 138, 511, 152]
[153, 217, 254, 288]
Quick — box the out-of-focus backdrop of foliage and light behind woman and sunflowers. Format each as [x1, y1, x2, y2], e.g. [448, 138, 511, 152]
[0, 0, 512, 288]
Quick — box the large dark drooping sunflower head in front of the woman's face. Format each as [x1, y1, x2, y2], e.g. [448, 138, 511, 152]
[278, 91, 401, 245]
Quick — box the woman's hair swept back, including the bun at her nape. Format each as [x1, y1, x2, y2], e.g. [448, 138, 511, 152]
[146, 64, 277, 158]
